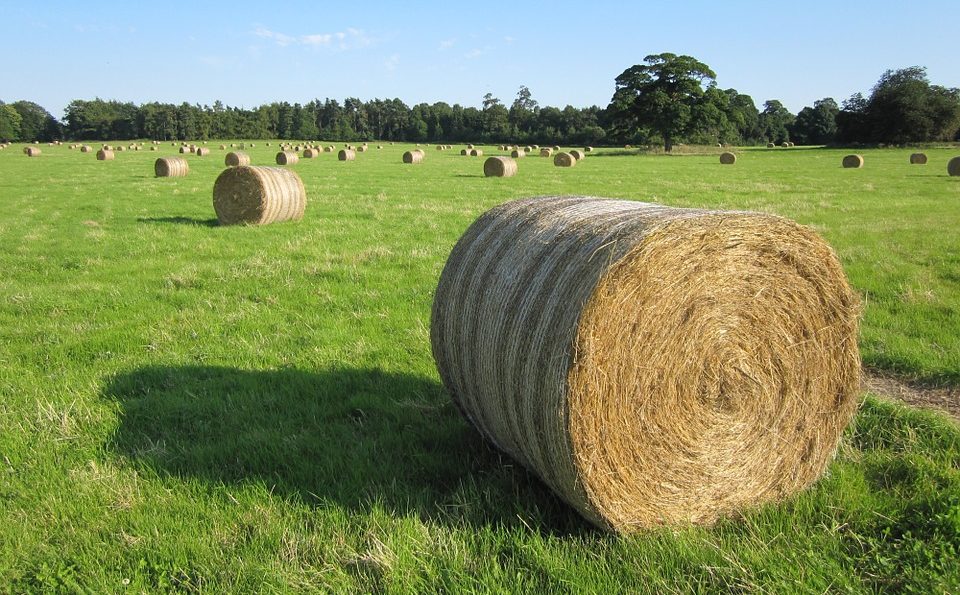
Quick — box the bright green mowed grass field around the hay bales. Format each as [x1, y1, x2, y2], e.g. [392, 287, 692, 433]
[0, 141, 960, 592]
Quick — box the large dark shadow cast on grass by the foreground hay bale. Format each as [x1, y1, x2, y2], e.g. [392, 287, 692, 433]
[103, 366, 593, 535]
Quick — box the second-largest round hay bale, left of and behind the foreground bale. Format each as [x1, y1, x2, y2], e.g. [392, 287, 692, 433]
[213, 165, 307, 225]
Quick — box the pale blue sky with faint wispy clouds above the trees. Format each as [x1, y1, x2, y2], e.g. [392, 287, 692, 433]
[0, 0, 960, 117]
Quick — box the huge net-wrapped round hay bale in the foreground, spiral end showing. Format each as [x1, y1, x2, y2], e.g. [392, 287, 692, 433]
[430, 197, 860, 531]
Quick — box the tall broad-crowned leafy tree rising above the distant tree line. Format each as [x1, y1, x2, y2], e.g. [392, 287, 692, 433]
[608, 53, 717, 152]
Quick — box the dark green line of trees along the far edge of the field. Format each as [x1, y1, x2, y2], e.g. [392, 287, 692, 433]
[0, 53, 960, 151]
